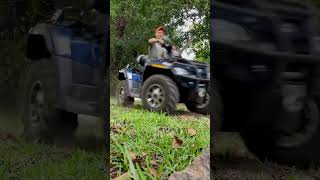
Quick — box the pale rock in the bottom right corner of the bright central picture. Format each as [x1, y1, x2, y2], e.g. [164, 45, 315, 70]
[168, 150, 210, 180]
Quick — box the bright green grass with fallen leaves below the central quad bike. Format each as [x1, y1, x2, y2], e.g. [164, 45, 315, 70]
[110, 99, 210, 178]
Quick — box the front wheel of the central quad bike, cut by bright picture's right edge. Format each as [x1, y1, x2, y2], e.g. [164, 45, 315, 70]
[185, 93, 210, 115]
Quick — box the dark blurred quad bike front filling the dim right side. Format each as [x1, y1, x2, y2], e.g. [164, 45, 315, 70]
[211, 0, 320, 166]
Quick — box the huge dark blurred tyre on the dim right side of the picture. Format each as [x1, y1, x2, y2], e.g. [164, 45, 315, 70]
[241, 92, 320, 168]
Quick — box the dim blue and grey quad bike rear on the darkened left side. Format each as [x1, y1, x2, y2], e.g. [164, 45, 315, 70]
[21, 1, 108, 143]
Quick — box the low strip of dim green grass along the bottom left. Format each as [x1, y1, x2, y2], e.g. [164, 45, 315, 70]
[0, 139, 107, 179]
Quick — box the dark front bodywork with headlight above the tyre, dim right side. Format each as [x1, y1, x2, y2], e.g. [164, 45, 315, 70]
[211, 0, 320, 131]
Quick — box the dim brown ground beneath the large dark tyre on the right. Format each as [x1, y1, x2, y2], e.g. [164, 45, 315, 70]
[211, 133, 320, 180]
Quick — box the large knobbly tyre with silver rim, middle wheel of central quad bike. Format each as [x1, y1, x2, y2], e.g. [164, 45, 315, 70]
[142, 75, 180, 114]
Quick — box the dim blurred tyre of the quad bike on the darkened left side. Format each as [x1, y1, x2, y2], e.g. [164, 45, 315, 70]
[21, 59, 78, 143]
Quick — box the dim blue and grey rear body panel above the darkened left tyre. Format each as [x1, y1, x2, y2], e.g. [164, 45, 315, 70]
[27, 18, 105, 116]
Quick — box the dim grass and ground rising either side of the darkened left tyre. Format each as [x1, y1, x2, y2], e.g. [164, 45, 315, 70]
[0, 108, 107, 180]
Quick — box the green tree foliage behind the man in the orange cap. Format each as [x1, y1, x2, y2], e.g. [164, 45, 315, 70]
[110, 0, 210, 69]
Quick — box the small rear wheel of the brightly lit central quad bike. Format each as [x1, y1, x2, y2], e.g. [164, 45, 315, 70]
[116, 80, 134, 107]
